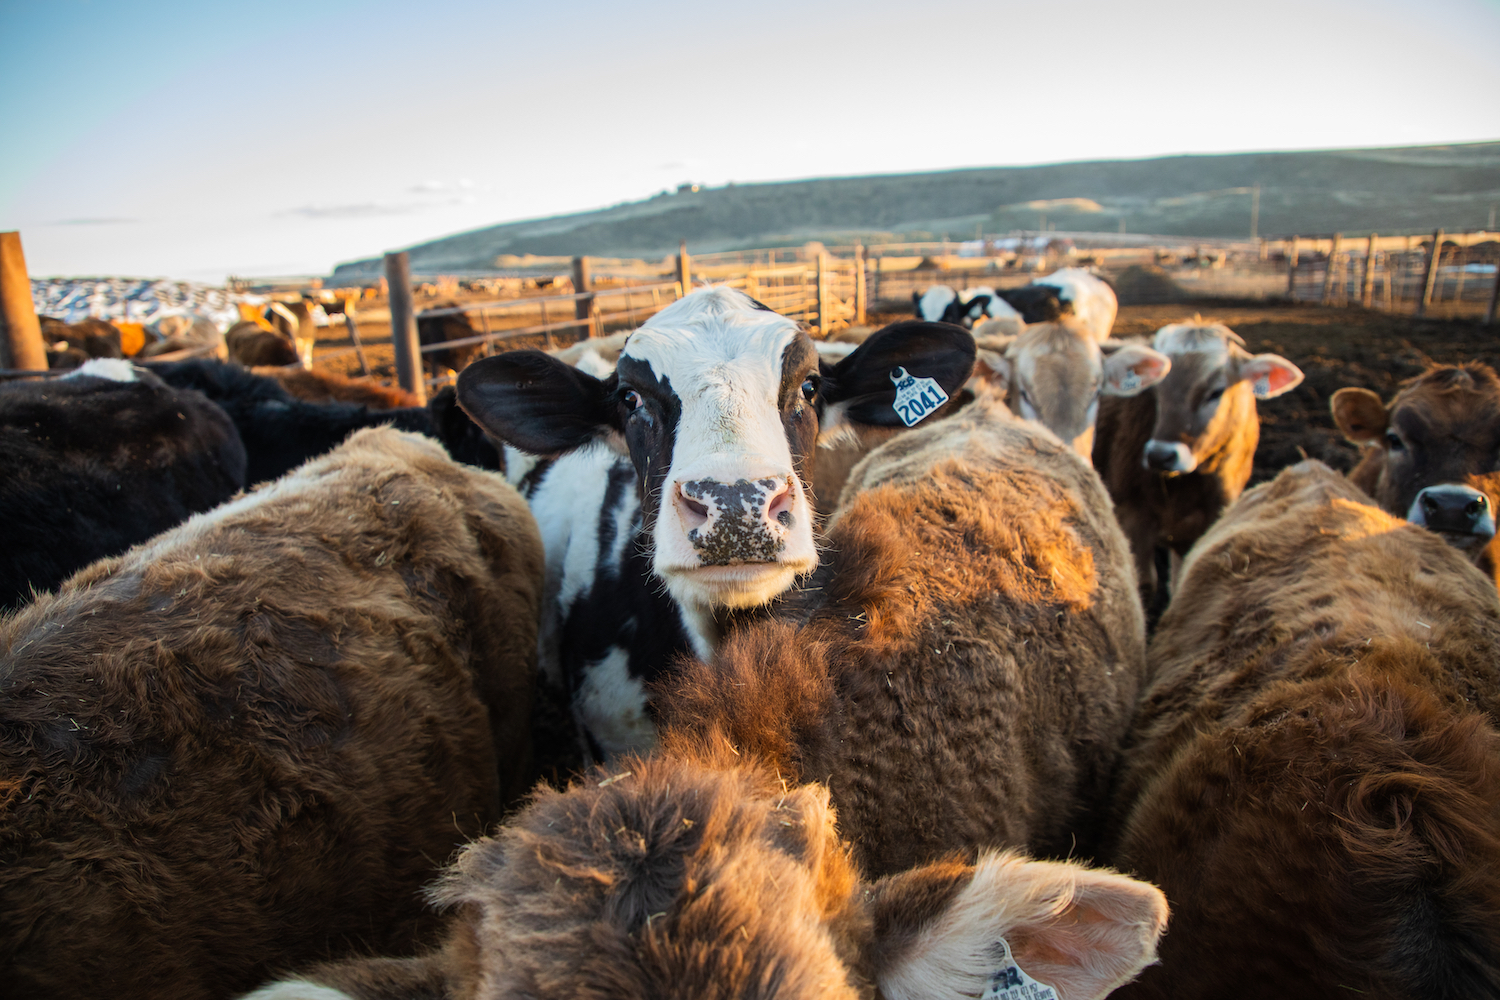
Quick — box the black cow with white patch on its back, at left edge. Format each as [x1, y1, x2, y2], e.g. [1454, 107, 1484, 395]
[0, 358, 246, 610]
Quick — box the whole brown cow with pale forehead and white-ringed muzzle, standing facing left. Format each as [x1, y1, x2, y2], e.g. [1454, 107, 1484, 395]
[1094, 321, 1302, 622]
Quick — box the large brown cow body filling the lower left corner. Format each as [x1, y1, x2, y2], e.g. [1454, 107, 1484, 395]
[0, 429, 543, 1000]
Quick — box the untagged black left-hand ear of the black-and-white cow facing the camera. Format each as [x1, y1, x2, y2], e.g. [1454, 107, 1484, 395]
[458, 351, 621, 454]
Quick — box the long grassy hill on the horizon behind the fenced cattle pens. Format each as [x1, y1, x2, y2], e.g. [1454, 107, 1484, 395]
[335, 142, 1500, 279]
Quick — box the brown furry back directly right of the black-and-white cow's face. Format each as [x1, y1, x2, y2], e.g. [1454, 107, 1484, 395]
[659, 403, 1145, 874]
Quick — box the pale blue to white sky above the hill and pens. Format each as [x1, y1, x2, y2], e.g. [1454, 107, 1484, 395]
[0, 0, 1500, 282]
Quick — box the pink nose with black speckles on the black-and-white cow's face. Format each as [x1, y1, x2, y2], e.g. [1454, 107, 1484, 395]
[674, 477, 795, 565]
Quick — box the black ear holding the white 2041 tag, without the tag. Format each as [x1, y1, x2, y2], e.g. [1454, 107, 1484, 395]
[822, 321, 974, 427]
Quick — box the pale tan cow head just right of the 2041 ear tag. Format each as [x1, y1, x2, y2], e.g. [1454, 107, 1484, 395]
[986, 319, 1172, 462]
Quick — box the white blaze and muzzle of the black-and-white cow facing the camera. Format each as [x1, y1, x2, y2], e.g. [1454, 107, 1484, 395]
[620, 288, 818, 607]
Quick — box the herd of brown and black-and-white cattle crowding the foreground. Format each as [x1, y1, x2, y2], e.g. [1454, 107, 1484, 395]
[0, 280, 1500, 1000]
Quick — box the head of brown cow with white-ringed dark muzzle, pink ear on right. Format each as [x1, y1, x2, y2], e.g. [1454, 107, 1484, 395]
[1142, 322, 1302, 475]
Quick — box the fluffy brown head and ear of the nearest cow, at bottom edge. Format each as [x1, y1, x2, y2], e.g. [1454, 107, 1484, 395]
[414, 756, 1167, 1000]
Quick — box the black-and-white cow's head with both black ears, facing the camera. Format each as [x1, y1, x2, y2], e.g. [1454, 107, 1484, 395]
[458, 288, 974, 612]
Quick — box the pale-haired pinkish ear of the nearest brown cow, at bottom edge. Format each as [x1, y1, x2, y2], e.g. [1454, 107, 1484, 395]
[869, 853, 1167, 1000]
